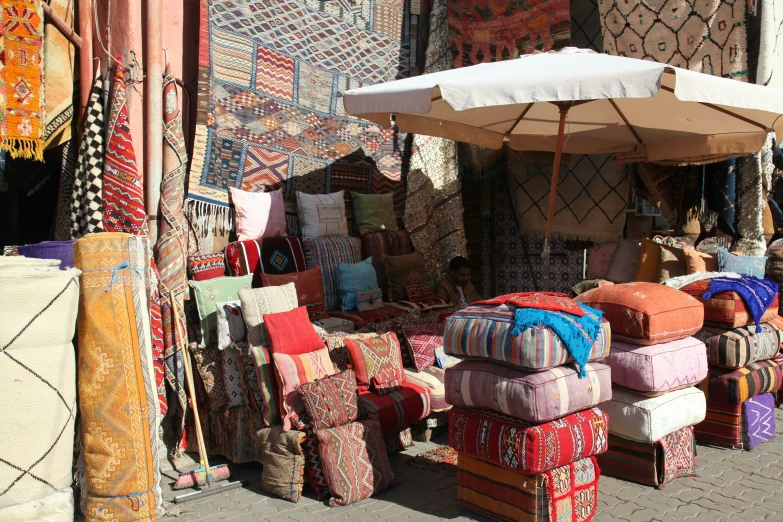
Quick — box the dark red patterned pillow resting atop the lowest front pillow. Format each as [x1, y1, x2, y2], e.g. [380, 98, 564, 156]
[298, 370, 359, 431]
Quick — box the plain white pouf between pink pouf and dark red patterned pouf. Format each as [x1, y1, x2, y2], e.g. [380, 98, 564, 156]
[599, 387, 707, 442]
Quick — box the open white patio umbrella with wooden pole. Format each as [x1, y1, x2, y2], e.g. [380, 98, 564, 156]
[343, 47, 783, 255]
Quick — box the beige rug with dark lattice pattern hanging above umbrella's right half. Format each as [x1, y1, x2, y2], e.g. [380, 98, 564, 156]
[598, 0, 752, 81]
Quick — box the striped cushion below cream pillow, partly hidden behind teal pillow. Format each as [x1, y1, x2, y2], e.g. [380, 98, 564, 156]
[302, 236, 362, 310]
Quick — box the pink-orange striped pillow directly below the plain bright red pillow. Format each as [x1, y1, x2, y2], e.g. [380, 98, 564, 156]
[272, 348, 335, 431]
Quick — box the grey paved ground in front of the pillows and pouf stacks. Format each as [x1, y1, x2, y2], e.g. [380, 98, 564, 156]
[159, 410, 783, 522]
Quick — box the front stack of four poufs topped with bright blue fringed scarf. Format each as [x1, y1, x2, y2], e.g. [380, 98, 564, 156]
[444, 293, 612, 521]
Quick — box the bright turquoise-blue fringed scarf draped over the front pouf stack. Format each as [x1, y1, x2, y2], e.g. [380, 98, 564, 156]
[511, 303, 604, 377]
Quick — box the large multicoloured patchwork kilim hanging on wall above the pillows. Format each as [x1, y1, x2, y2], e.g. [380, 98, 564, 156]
[187, 0, 419, 250]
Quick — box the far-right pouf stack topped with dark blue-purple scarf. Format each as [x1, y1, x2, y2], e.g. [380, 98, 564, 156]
[682, 274, 783, 450]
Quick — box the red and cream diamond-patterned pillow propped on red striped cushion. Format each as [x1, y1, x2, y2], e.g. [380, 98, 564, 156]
[345, 332, 405, 395]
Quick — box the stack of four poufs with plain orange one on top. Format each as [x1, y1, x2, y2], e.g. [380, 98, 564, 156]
[577, 283, 707, 488]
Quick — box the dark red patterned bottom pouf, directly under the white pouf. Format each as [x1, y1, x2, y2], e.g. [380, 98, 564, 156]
[597, 426, 696, 489]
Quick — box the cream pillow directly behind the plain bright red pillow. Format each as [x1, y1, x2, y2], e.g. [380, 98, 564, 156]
[239, 276, 299, 346]
